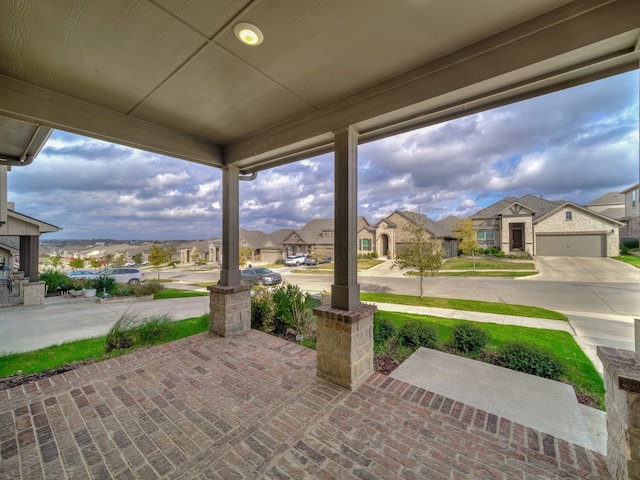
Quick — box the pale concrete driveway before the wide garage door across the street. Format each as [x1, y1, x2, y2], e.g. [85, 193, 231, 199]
[526, 257, 640, 284]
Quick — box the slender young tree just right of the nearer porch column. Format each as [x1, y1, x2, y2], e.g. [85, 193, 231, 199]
[393, 219, 445, 298]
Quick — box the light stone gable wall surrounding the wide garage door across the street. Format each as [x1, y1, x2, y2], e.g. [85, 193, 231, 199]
[535, 208, 620, 257]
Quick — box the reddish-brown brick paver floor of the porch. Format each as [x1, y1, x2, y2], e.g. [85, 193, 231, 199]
[0, 331, 609, 480]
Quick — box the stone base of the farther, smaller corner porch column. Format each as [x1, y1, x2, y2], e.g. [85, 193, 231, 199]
[207, 285, 251, 337]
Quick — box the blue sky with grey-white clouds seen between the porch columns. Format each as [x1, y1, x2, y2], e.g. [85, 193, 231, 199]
[8, 71, 640, 240]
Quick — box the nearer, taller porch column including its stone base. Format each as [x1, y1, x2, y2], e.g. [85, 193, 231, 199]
[313, 127, 377, 390]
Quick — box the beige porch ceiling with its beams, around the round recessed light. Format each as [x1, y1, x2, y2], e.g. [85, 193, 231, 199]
[0, 0, 640, 173]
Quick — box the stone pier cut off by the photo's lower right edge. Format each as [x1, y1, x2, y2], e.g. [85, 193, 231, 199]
[598, 347, 640, 480]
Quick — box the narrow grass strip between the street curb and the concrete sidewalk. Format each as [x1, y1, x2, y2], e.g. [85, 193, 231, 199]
[360, 292, 568, 320]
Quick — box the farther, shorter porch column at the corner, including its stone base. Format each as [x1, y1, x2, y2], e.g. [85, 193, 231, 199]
[208, 165, 251, 337]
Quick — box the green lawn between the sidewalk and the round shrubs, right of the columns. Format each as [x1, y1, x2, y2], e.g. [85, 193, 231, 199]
[380, 311, 604, 409]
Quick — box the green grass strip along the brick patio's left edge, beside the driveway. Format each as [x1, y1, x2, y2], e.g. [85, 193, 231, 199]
[0, 314, 209, 378]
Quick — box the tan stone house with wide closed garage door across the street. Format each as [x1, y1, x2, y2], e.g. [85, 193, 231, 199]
[471, 195, 623, 257]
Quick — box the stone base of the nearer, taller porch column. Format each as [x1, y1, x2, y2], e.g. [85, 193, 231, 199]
[313, 303, 378, 390]
